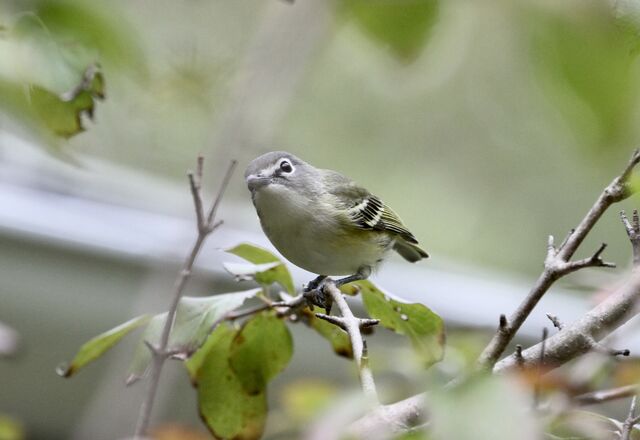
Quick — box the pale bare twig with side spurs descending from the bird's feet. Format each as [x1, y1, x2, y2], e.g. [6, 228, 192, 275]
[316, 281, 379, 405]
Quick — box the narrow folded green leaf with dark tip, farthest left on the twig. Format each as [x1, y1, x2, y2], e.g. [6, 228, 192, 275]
[56, 315, 151, 377]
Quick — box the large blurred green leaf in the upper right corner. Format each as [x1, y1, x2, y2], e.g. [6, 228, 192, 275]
[522, 1, 638, 148]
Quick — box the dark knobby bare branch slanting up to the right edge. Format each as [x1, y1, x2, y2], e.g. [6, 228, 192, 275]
[478, 149, 640, 369]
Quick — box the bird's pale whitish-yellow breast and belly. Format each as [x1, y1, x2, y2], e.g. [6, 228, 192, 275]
[255, 189, 388, 275]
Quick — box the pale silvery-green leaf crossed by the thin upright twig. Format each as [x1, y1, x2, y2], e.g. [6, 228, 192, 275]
[127, 289, 260, 384]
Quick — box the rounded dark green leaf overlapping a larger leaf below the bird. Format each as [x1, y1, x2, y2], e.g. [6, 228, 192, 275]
[229, 312, 293, 394]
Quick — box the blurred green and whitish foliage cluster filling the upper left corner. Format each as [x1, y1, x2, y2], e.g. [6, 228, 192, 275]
[0, 0, 145, 142]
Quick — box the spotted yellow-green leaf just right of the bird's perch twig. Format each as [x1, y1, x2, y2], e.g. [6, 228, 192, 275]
[356, 281, 444, 367]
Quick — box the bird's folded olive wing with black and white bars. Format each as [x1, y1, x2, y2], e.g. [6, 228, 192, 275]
[323, 170, 418, 243]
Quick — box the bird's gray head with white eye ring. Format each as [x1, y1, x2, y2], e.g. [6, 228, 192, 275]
[244, 151, 317, 192]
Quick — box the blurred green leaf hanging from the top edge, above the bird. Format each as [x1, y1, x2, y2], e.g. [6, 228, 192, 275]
[337, 0, 438, 61]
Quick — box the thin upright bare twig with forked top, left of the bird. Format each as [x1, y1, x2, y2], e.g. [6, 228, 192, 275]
[135, 156, 236, 438]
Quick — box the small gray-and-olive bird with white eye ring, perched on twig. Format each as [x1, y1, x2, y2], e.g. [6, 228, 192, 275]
[245, 151, 429, 290]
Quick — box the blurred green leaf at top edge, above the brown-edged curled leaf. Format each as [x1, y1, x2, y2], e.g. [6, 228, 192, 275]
[26, 0, 146, 73]
